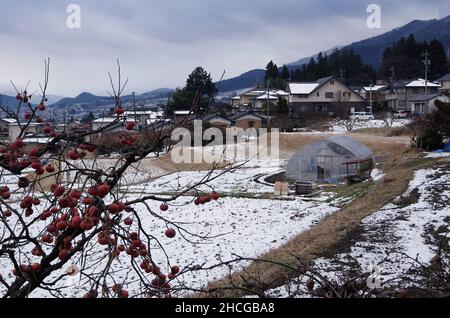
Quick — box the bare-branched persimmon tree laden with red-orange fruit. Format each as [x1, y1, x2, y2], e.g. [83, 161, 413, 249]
[0, 60, 232, 298]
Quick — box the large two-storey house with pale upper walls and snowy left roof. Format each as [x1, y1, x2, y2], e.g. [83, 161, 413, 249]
[288, 76, 368, 118]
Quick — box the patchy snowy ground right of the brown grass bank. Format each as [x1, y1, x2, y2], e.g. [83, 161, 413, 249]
[269, 167, 450, 297]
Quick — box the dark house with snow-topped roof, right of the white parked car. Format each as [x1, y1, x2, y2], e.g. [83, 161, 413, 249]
[383, 78, 441, 111]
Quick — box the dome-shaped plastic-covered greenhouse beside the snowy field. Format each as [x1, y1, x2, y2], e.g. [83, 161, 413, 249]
[286, 136, 373, 182]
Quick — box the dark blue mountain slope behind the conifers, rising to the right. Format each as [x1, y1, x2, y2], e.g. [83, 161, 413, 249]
[220, 16, 450, 92]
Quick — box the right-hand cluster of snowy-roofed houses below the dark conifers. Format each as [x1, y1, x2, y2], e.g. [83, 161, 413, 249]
[230, 74, 450, 119]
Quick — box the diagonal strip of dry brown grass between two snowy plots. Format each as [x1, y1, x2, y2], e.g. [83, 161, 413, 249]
[205, 150, 446, 297]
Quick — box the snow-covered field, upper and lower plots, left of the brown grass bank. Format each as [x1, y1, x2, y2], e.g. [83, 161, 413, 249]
[0, 154, 338, 297]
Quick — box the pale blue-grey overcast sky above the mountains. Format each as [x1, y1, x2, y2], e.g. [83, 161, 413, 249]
[0, 0, 450, 96]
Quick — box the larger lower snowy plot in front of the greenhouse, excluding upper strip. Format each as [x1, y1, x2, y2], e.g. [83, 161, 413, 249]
[0, 186, 338, 297]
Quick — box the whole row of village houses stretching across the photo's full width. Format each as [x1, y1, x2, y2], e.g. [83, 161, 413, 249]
[0, 74, 450, 152]
